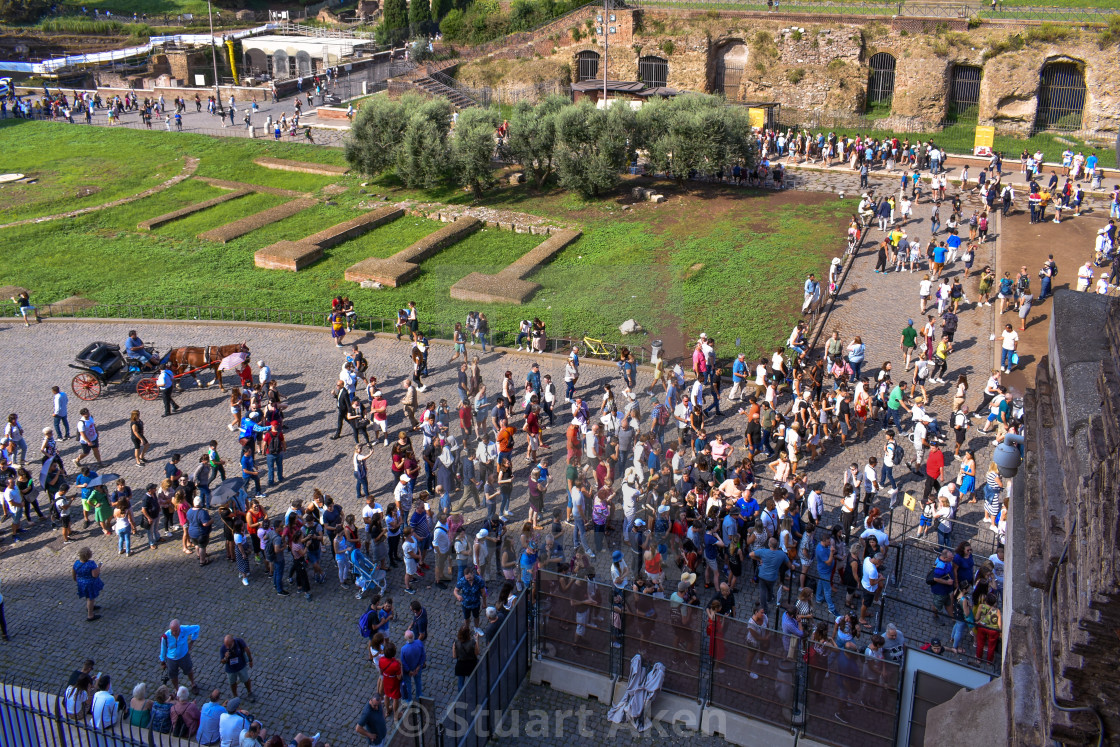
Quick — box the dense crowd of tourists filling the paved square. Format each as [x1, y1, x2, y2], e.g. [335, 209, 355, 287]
[0, 129, 1120, 747]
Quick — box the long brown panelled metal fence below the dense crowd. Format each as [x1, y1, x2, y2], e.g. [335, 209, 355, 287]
[536, 570, 905, 734]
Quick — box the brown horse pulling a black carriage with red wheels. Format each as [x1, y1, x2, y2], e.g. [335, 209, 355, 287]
[69, 342, 249, 401]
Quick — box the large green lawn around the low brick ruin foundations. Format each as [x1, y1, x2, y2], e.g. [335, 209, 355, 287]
[0, 122, 852, 354]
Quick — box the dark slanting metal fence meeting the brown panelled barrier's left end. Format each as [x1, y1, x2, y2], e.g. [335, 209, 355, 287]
[436, 594, 531, 747]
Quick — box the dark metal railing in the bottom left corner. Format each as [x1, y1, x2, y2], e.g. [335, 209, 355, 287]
[0, 683, 153, 747]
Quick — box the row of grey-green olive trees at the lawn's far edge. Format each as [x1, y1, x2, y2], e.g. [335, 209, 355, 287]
[345, 91, 758, 197]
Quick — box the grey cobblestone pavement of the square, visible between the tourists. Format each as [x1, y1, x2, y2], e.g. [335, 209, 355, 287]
[0, 167, 1008, 744]
